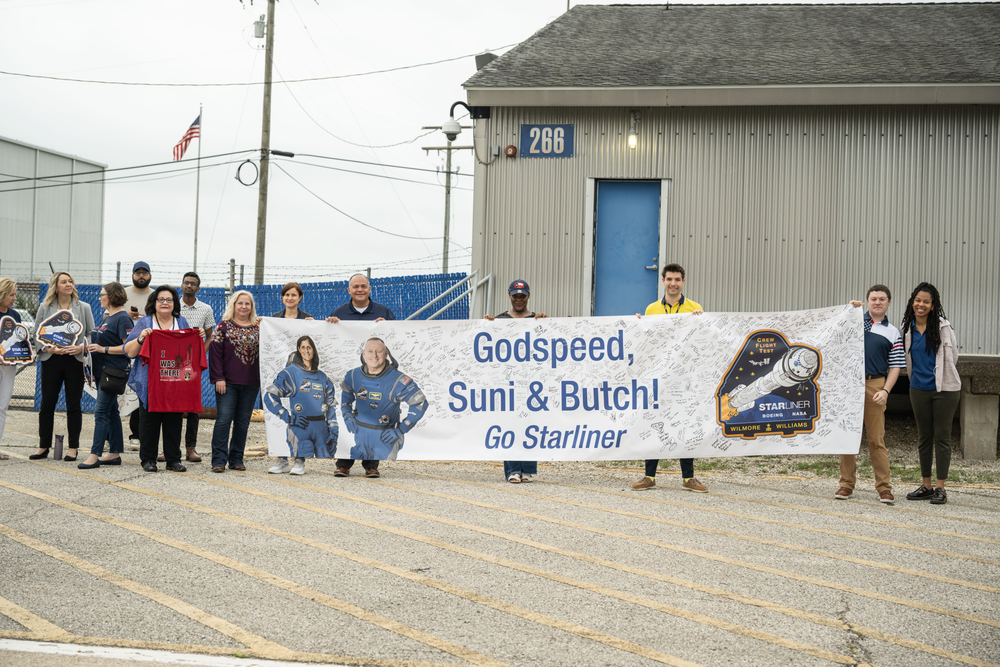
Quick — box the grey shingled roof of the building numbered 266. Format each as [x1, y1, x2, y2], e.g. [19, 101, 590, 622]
[464, 2, 1000, 105]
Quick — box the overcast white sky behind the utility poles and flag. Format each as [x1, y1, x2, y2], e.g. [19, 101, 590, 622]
[0, 0, 968, 284]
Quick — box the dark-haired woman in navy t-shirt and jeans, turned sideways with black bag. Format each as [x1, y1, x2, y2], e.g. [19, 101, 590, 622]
[76, 283, 133, 470]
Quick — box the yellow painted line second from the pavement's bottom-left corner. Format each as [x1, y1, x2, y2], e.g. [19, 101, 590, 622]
[0, 520, 290, 658]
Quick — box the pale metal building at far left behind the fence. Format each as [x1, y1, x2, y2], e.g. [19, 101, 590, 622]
[0, 137, 107, 282]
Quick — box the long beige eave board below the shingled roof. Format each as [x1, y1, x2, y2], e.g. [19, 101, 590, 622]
[466, 82, 1000, 107]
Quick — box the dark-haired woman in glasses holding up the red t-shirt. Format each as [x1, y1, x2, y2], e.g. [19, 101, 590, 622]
[125, 285, 198, 472]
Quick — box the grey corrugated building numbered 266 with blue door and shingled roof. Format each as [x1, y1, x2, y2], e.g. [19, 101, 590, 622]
[464, 3, 1000, 354]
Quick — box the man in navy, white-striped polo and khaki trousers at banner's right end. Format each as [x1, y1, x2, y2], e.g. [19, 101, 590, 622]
[833, 285, 906, 504]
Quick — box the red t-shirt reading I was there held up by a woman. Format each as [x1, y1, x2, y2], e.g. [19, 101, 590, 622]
[139, 329, 208, 412]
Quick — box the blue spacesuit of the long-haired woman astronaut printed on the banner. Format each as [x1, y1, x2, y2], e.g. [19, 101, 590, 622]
[263, 364, 340, 458]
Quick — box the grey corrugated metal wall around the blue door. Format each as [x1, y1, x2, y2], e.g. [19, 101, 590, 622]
[472, 106, 1000, 354]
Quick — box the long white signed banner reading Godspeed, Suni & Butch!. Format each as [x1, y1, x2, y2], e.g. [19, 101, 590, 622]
[260, 306, 865, 460]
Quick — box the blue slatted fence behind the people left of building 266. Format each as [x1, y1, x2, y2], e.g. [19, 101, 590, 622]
[35, 273, 469, 412]
